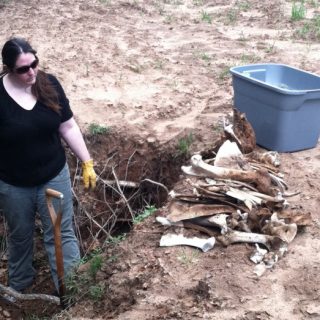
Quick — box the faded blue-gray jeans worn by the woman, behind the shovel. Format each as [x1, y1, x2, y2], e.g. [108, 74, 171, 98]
[0, 164, 80, 291]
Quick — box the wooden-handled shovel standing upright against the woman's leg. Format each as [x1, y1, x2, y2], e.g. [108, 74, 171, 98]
[46, 189, 66, 309]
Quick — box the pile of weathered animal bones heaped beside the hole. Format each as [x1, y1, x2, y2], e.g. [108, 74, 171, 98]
[156, 110, 311, 276]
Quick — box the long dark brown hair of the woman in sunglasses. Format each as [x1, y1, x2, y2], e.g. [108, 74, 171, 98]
[0, 38, 60, 113]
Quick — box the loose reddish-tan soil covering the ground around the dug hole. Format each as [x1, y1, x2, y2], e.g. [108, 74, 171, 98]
[0, 0, 320, 320]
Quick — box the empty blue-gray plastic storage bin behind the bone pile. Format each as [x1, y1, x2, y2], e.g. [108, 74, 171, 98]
[230, 64, 320, 152]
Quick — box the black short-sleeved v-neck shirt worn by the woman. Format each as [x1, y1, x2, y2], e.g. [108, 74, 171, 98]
[0, 75, 73, 187]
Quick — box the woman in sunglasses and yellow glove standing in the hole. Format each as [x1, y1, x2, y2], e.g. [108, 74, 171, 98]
[0, 38, 96, 291]
